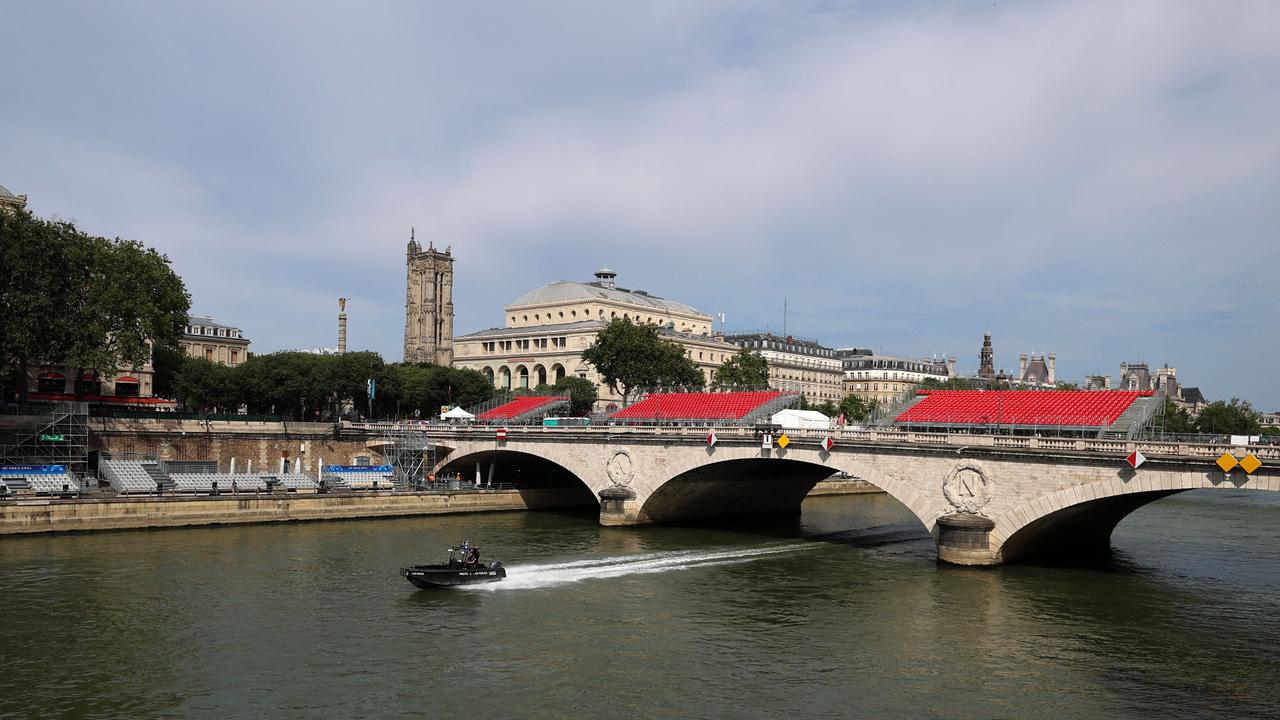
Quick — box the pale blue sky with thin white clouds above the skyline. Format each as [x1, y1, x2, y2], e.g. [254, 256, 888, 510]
[0, 0, 1280, 410]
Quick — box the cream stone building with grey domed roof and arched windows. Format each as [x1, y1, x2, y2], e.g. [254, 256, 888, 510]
[453, 268, 737, 409]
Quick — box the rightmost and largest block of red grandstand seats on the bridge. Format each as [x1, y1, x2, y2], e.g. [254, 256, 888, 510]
[896, 389, 1151, 428]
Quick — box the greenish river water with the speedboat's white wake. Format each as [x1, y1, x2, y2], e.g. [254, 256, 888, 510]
[0, 491, 1280, 720]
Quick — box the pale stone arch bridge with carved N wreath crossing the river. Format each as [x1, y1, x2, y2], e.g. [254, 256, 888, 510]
[412, 425, 1280, 565]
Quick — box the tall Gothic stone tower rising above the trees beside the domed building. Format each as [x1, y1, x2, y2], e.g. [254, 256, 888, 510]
[404, 231, 453, 366]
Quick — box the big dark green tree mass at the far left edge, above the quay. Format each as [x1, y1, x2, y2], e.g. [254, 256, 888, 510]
[0, 210, 191, 400]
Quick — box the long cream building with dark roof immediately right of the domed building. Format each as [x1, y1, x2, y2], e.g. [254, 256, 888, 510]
[724, 332, 845, 405]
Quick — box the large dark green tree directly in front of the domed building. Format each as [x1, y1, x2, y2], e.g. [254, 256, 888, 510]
[582, 319, 704, 405]
